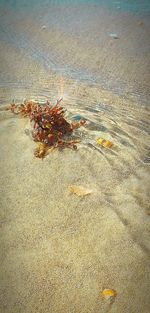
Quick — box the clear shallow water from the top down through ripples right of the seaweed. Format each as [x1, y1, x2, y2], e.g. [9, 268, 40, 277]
[0, 1, 150, 186]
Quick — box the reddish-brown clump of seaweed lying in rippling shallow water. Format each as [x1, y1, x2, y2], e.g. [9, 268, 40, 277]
[10, 98, 85, 158]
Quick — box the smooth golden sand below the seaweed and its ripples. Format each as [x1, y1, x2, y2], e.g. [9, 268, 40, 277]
[0, 106, 149, 313]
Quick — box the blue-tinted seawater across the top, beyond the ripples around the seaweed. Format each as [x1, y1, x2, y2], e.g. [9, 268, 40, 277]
[0, 0, 150, 102]
